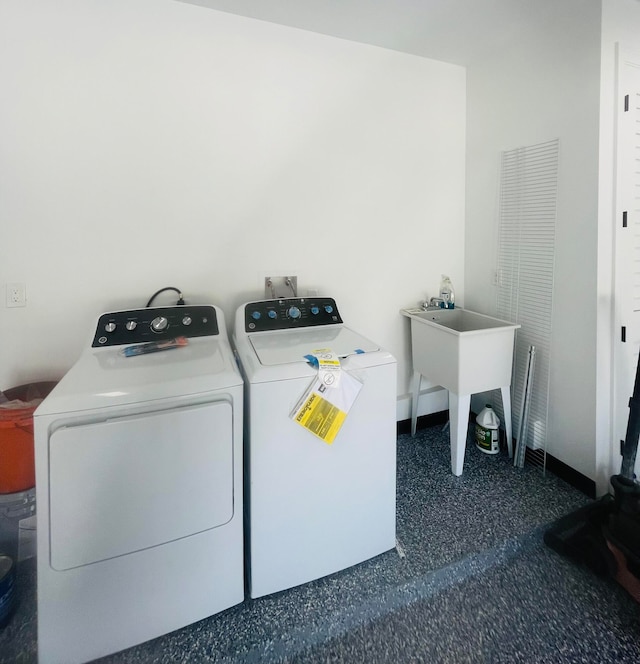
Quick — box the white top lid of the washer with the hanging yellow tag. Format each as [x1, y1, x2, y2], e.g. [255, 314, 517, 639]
[248, 325, 380, 366]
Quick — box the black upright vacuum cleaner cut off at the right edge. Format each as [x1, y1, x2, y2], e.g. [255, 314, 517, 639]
[544, 355, 640, 602]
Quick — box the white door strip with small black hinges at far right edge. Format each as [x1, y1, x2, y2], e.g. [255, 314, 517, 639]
[611, 48, 640, 482]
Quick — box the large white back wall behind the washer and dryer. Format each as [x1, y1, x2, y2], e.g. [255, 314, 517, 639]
[0, 0, 465, 417]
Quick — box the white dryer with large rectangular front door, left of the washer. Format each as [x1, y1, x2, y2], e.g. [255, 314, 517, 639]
[34, 305, 244, 664]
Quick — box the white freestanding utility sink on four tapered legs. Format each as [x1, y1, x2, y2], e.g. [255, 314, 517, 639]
[400, 308, 520, 475]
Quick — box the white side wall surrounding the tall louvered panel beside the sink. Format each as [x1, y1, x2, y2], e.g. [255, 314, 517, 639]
[465, 0, 600, 479]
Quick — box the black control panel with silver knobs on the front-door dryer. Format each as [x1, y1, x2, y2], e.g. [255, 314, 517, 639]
[91, 305, 219, 348]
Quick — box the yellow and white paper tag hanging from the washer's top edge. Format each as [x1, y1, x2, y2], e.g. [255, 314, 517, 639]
[291, 348, 362, 445]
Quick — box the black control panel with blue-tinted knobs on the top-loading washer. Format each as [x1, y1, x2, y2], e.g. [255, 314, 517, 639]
[244, 297, 342, 332]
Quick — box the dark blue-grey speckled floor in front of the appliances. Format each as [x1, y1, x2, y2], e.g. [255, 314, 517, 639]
[0, 426, 640, 664]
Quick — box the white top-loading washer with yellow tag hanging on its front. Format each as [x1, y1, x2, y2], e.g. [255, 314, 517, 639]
[234, 297, 397, 597]
